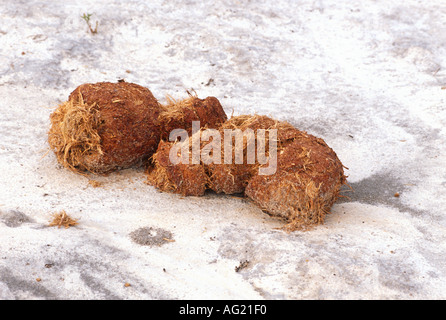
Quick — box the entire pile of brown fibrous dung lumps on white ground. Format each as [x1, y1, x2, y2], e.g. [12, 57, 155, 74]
[48, 82, 346, 231]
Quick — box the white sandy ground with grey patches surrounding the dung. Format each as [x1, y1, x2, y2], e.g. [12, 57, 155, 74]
[0, 0, 446, 299]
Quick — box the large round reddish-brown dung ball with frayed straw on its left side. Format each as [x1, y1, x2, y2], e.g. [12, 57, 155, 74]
[48, 82, 162, 173]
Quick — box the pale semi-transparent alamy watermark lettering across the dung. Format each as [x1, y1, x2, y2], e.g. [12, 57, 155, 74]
[169, 121, 277, 175]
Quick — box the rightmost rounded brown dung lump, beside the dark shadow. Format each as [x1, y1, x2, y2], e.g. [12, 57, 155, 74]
[245, 124, 346, 231]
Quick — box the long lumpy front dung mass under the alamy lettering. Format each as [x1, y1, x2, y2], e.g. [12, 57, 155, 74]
[148, 115, 346, 230]
